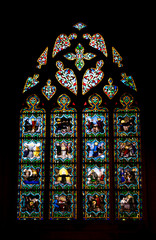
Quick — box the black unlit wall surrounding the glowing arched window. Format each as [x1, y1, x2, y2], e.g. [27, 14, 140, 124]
[0, 1, 156, 240]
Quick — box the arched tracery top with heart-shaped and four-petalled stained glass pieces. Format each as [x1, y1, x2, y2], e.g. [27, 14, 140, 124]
[23, 22, 137, 101]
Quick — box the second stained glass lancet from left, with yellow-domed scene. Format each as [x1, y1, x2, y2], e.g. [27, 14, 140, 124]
[50, 94, 77, 220]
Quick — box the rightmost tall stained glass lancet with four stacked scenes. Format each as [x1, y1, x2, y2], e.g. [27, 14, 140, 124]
[114, 94, 142, 219]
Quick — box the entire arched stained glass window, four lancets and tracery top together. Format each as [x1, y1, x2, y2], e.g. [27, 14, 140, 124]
[17, 22, 143, 220]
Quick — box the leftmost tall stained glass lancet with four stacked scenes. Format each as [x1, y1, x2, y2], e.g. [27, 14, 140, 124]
[17, 95, 46, 220]
